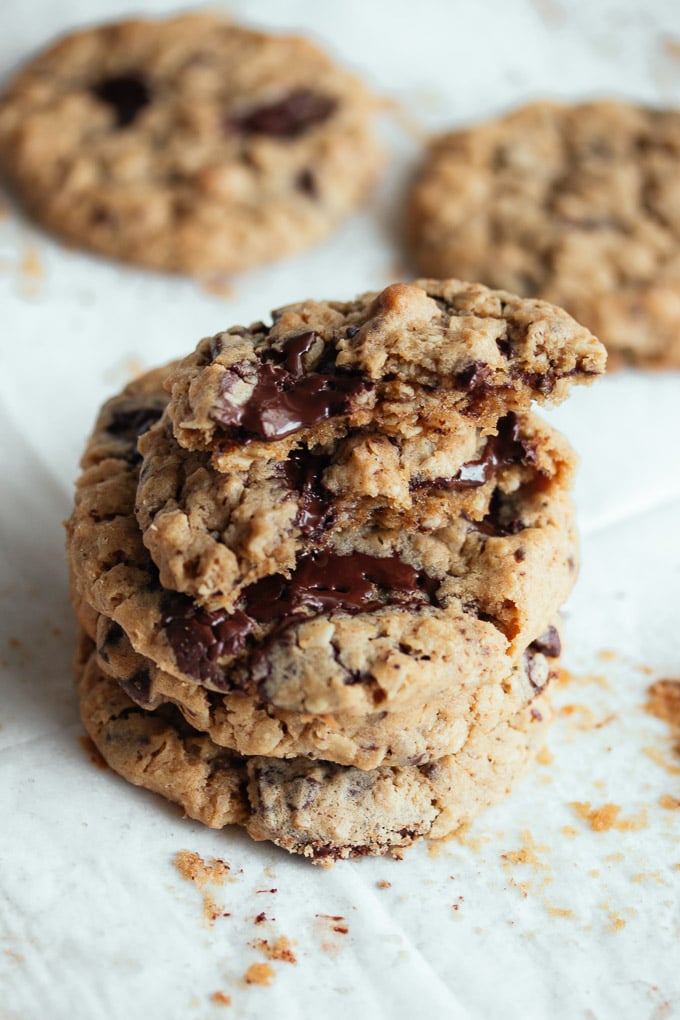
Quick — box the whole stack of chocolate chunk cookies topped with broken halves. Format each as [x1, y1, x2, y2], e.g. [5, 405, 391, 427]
[67, 281, 605, 863]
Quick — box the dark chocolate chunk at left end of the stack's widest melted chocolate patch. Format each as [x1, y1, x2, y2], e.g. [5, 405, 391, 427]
[161, 595, 253, 684]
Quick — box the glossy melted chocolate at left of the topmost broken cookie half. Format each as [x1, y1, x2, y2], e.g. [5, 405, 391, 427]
[213, 332, 369, 442]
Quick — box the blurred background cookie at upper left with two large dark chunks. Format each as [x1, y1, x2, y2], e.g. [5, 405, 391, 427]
[0, 13, 382, 274]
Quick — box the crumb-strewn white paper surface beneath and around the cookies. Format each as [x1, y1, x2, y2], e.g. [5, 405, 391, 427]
[0, 0, 680, 1020]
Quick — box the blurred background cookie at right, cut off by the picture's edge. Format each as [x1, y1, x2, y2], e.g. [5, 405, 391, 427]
[407, 102, 680, 368]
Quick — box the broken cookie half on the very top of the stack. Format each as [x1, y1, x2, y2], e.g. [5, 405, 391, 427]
[166, 279, 606, 459]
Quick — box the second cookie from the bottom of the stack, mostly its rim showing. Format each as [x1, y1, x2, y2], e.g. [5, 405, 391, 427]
[89, 599, 561, 769]
